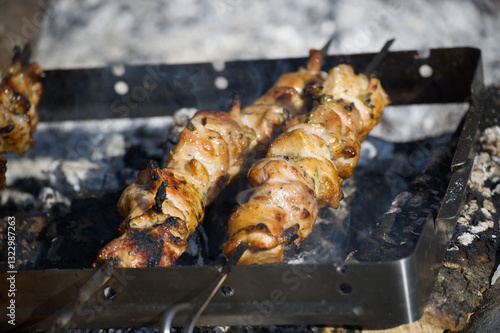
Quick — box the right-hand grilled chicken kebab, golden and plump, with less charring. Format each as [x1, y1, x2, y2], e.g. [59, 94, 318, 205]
[224, 65, 390, 264]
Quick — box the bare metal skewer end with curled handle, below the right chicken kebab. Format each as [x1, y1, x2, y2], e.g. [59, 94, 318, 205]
[160, 243, 248, 333]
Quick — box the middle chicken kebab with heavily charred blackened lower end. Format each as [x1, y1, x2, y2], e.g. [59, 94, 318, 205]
[94, 50, 325, 267]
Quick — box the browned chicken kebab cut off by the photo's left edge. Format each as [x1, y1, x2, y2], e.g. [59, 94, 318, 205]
[0, 57, 43, 189]
